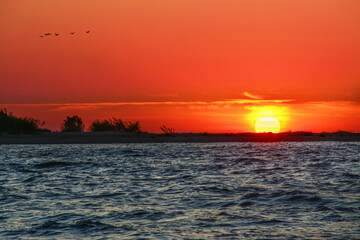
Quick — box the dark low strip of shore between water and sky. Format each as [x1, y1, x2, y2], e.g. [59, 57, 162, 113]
[0, 132, 360, 144]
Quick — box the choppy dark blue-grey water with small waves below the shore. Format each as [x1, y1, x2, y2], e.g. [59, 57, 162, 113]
[0, 142, 360, 239]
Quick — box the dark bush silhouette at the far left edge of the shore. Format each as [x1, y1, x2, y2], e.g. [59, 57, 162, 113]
[0, 108, 50, 134]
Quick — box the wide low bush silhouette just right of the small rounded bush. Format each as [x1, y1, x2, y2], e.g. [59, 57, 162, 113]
[89, 117, 143, 133]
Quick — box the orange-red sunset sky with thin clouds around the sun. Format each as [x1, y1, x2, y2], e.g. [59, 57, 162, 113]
[0, 0, 360, 132]
